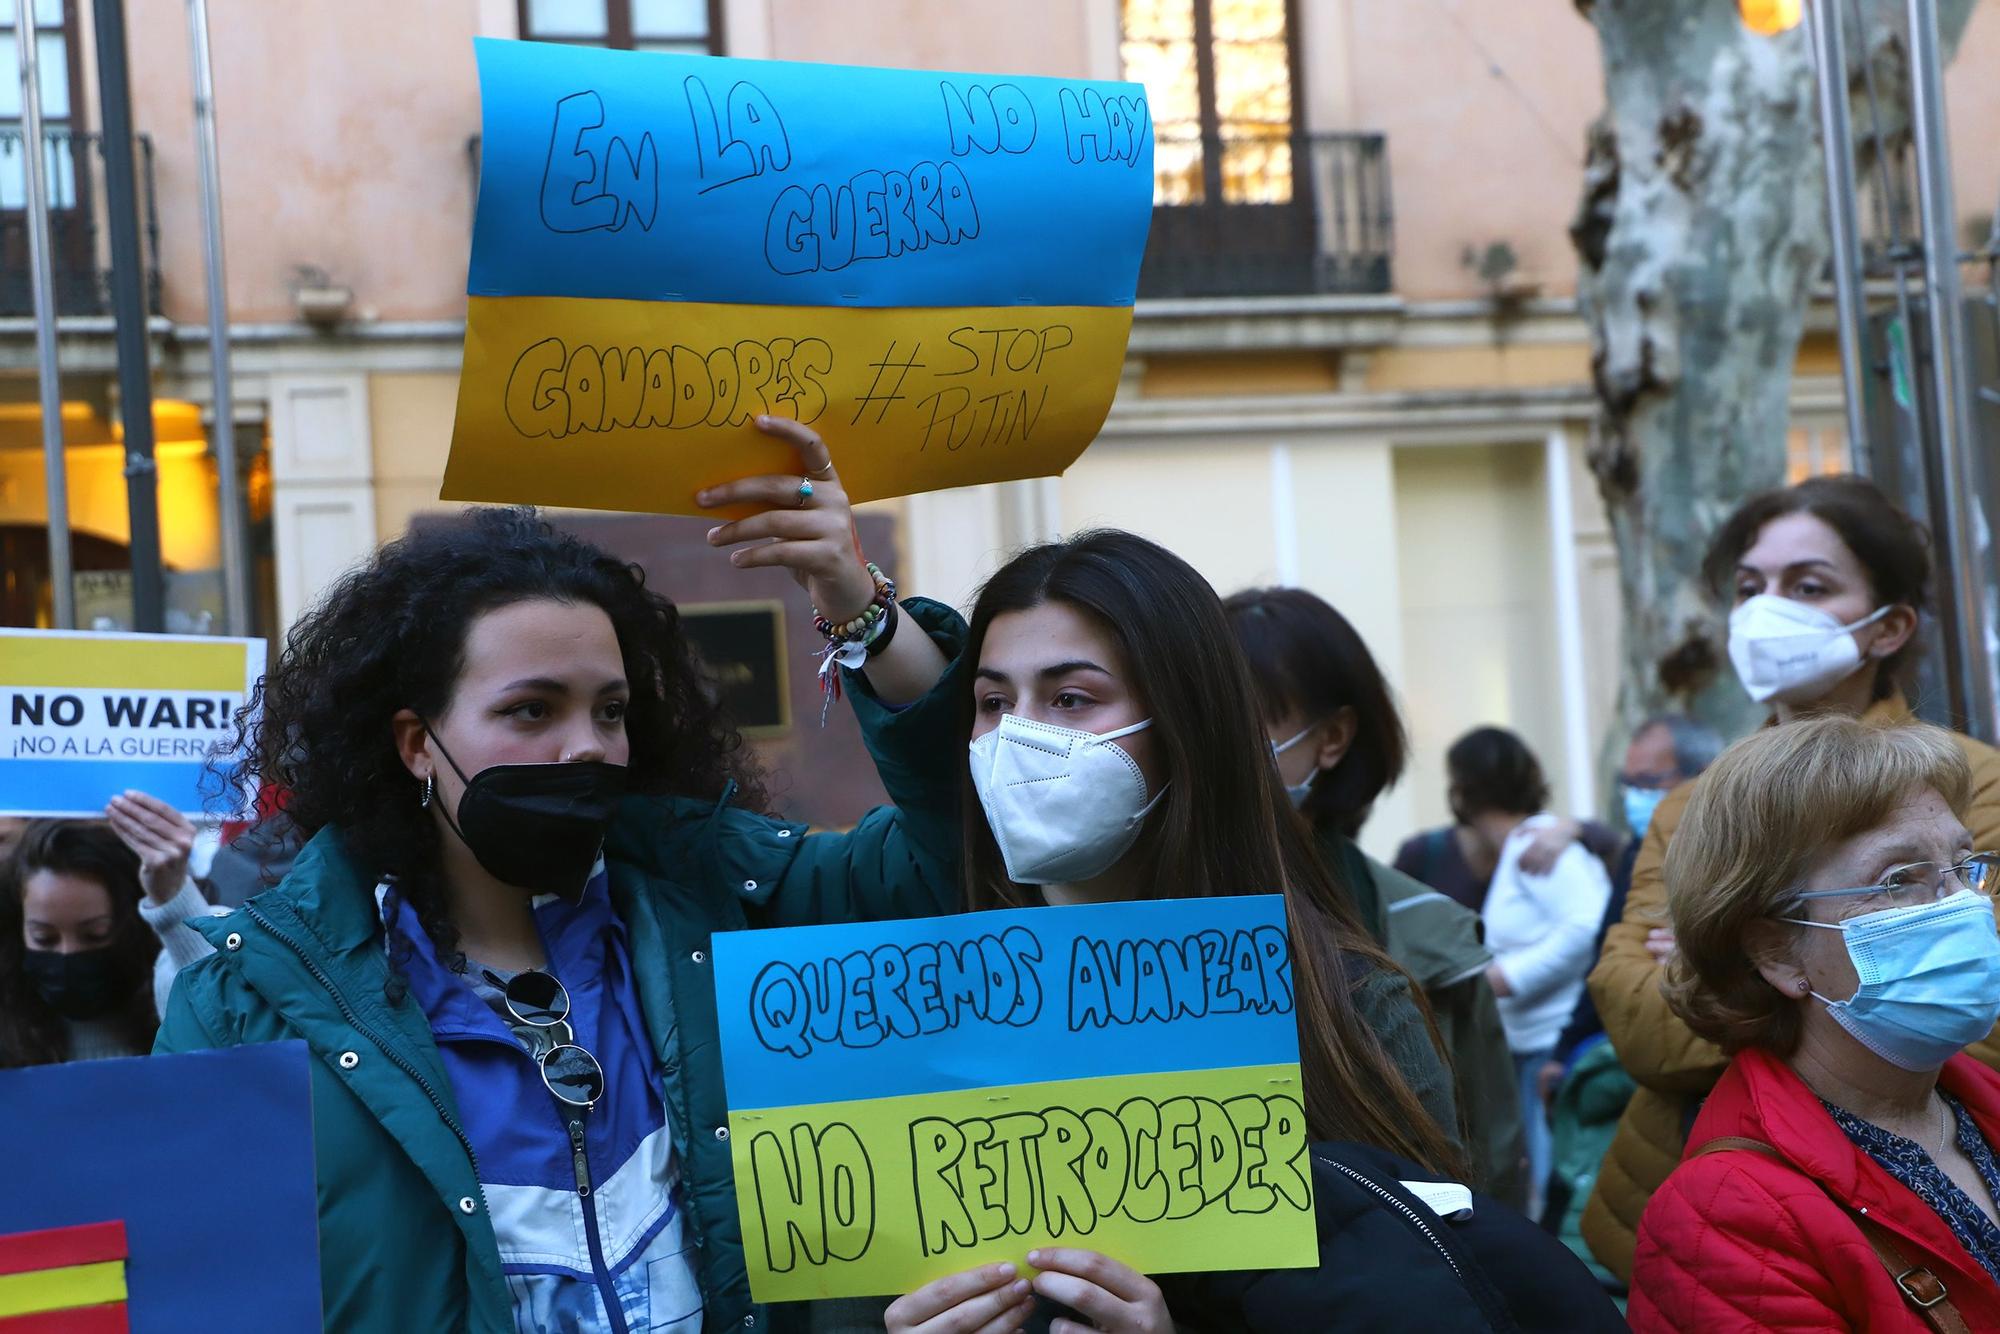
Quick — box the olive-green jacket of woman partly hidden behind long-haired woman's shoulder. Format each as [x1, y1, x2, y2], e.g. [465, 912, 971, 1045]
[1316, 830, 1528, 1208]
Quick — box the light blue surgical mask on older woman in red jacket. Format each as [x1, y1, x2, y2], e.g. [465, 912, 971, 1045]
[1784, 890, 2000, 1070]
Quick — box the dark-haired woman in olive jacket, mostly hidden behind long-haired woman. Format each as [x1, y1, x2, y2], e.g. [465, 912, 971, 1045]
[1224, 588, 1528, 1206]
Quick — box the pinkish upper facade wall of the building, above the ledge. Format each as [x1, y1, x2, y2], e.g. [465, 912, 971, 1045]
[94, 0, 2000, 320]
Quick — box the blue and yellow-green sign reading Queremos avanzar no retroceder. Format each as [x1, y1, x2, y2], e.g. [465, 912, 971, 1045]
[714, 896, 1318, 1302]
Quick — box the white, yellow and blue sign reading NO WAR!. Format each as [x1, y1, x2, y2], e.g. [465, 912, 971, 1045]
[0, 630, 264, 816]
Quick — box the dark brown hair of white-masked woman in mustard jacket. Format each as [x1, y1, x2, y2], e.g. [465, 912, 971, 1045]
[1702, 476, 1930, 700]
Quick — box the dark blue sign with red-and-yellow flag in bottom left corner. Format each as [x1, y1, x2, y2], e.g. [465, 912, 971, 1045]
[0, 1042, 322, 1334]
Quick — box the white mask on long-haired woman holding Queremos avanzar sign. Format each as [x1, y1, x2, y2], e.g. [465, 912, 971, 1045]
[972, 714, 1166, 884]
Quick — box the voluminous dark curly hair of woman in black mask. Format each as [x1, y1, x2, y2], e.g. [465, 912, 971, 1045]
[246, 508, 764, 984]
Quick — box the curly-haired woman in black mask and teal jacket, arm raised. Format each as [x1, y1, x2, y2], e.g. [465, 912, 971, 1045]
[158, 418, 962, 1334]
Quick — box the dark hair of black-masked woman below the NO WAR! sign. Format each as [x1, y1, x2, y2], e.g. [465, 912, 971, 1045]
[0, 820, 160, 1068]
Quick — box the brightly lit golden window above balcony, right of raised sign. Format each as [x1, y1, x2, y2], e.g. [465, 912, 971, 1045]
[1120, 0, 1298, 204]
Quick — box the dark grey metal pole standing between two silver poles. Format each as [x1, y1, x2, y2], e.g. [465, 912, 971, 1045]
[92, 0, 166, 634]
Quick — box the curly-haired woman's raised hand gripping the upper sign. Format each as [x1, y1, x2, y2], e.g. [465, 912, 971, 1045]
[694, 416, 874, 624]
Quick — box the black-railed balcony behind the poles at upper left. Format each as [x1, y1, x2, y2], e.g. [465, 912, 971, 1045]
[0, 126, 160, 316]
